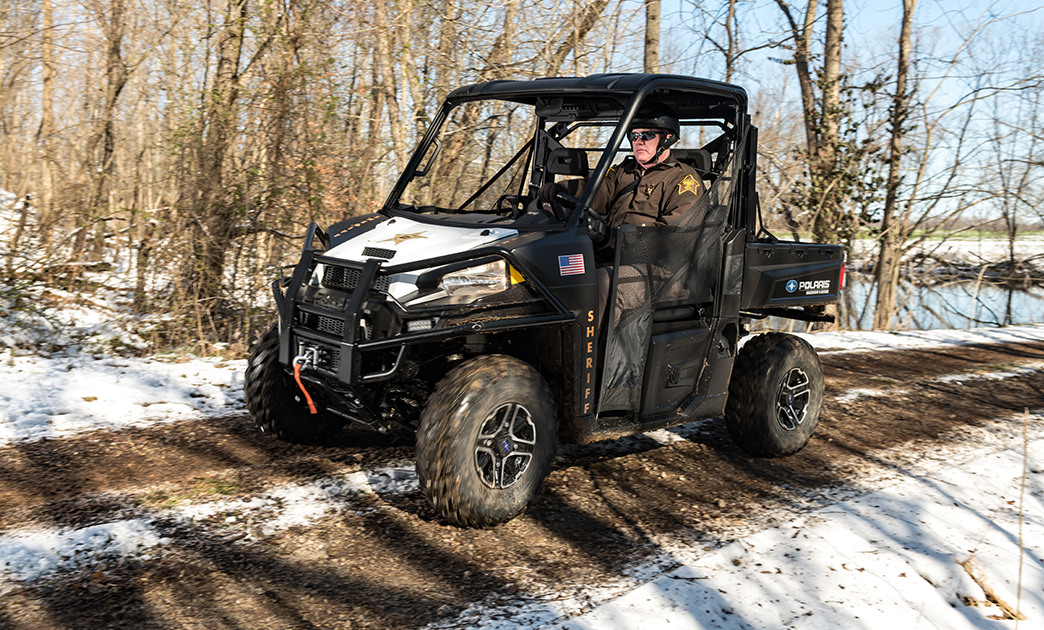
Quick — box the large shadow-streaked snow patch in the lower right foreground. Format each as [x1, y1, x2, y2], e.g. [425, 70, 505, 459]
[442, 440, 1044, 630]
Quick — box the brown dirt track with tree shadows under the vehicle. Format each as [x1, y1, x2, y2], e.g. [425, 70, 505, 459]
[0, 343, 1044, 629]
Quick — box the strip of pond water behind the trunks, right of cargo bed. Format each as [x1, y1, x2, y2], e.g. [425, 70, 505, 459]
[841, 273, 1044, 330]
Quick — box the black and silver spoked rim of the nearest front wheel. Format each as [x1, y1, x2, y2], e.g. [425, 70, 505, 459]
[475, 402, 537, 490]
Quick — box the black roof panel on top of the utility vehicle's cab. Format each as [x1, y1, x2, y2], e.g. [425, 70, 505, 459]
[447, 73, 746, 111]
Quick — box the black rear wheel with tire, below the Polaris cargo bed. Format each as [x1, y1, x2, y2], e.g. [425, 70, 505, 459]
[725, 332, 823, 458]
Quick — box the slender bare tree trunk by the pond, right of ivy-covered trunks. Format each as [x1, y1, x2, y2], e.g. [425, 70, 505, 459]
[874, 0, 917, 330]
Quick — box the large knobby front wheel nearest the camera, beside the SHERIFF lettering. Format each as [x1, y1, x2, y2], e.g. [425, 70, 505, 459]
[417, 355, 559, 528]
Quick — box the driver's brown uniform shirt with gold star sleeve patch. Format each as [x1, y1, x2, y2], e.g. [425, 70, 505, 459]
[567, 157, 707, 228]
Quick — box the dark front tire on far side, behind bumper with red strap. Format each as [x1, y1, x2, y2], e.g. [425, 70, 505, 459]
[243, 326, 342, 443]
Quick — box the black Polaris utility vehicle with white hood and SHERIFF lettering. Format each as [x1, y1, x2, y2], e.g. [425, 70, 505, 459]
[245, 74, 844, 527]
